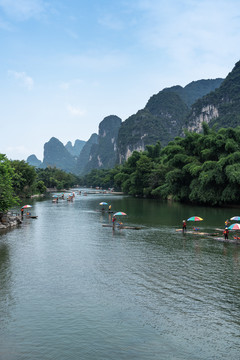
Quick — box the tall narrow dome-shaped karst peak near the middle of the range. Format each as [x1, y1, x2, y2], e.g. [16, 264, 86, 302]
[84, 115, 122, 172]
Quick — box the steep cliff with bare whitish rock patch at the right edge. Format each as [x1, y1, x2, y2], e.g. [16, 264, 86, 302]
[185, 61, 240, 132]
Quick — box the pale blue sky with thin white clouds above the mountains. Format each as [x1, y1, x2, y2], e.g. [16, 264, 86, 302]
[0, 0, 240, 160]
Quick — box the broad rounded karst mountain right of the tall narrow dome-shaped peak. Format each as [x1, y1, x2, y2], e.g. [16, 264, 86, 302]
[118, 91, 188, 164]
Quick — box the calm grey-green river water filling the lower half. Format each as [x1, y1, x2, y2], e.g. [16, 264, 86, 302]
[0, 194, 240, 360]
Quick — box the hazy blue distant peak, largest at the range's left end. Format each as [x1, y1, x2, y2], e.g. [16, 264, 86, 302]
[43, 137, 76, 172]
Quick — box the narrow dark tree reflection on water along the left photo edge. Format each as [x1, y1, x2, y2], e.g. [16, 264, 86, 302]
[0, 244, 12, 329]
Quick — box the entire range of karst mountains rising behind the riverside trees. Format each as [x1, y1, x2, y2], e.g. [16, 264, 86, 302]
[27, 61, 240, 175]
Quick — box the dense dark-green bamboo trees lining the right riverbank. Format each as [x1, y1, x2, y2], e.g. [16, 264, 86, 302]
[82, 124, 240, 205]
